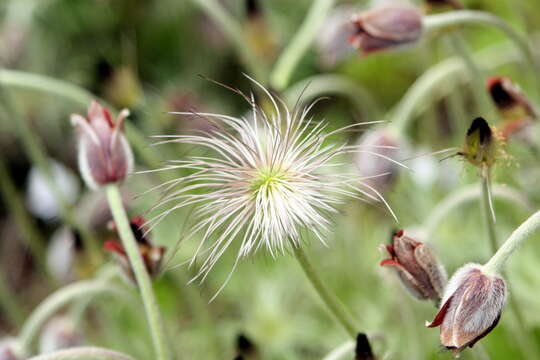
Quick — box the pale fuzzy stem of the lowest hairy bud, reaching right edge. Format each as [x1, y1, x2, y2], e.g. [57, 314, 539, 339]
[483, 211, 540, 275]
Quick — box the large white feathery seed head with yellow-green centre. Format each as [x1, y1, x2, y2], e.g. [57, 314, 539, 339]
[148, 82, 398, 279]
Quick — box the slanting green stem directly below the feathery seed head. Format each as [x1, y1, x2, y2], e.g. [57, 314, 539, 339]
[293, 245, 358, 339]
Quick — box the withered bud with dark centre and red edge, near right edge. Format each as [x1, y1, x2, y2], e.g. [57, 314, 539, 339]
[486, 76, 537, 138]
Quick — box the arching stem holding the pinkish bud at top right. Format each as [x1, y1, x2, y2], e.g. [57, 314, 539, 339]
[423, 10, 540, 96]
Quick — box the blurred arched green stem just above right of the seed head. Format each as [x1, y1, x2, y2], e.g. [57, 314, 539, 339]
[284, 74, 380, 118]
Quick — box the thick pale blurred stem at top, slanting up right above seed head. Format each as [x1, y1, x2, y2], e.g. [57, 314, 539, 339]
[270, 0, 335, 91]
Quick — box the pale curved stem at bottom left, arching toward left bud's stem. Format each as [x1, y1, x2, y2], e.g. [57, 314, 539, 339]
[19, 280, 129, 353]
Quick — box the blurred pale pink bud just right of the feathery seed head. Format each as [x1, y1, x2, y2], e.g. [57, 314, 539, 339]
[354, 129, 400, 192]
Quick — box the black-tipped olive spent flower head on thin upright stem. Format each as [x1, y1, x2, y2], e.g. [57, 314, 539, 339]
[458, 117, 497, 168]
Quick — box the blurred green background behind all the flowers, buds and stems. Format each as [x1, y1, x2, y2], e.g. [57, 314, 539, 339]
[0, 0, 540, 360]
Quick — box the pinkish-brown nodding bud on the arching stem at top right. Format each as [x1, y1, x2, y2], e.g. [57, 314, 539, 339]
[349, 4, 422, 55]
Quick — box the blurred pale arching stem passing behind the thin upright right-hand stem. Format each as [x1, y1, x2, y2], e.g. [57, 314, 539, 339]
[422, 185, 531, 239]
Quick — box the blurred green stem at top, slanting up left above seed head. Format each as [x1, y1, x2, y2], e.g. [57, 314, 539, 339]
[191, 0, 267, 83]
